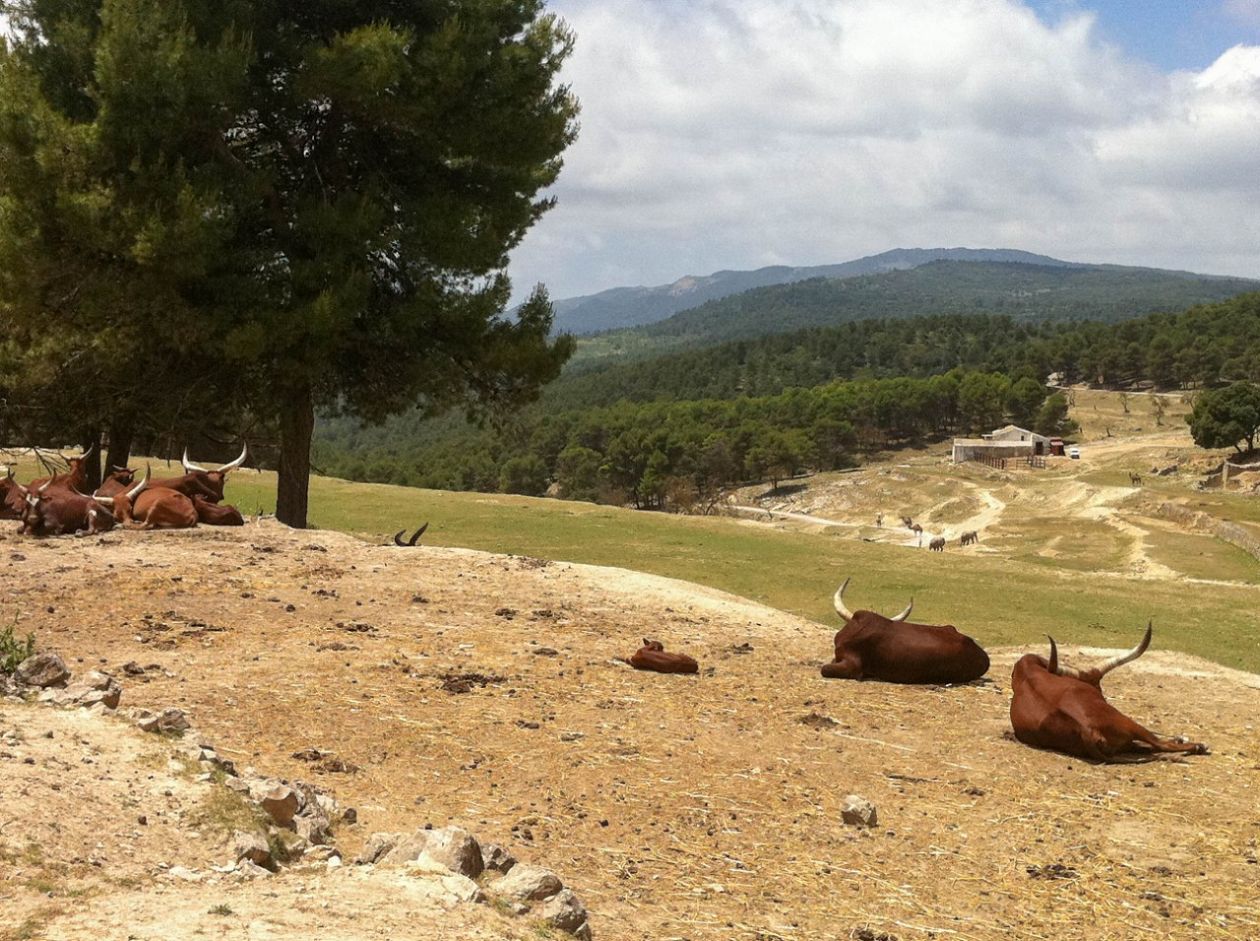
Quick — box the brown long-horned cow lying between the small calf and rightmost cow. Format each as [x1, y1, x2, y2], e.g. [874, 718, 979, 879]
[822, 578, 989, 683]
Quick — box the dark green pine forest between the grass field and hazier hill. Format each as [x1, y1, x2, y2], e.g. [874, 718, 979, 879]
[315, 292, 1260, 506]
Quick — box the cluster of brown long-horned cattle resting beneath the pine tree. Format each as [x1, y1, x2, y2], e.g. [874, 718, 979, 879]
[0, 448, 248, 537]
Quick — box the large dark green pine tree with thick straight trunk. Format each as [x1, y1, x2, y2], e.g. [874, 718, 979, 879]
[0, 0, 577, 527]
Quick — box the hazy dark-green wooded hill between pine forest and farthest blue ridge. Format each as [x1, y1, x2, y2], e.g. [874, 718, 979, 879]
[575, 261, 1260, 363]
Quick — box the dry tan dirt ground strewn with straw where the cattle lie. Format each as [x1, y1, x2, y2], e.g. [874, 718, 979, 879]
[0, 523, 1260, 941]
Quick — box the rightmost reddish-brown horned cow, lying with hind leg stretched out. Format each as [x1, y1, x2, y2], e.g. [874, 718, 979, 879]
[1011, 624, 1207, 762]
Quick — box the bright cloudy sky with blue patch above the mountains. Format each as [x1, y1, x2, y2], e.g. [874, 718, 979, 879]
[510, 0, 1260, 297]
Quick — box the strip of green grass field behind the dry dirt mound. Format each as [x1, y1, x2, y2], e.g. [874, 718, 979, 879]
[221, 471, 1260, 671]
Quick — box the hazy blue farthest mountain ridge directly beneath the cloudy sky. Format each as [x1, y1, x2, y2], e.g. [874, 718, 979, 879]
[552, 248, 1081, 336]
